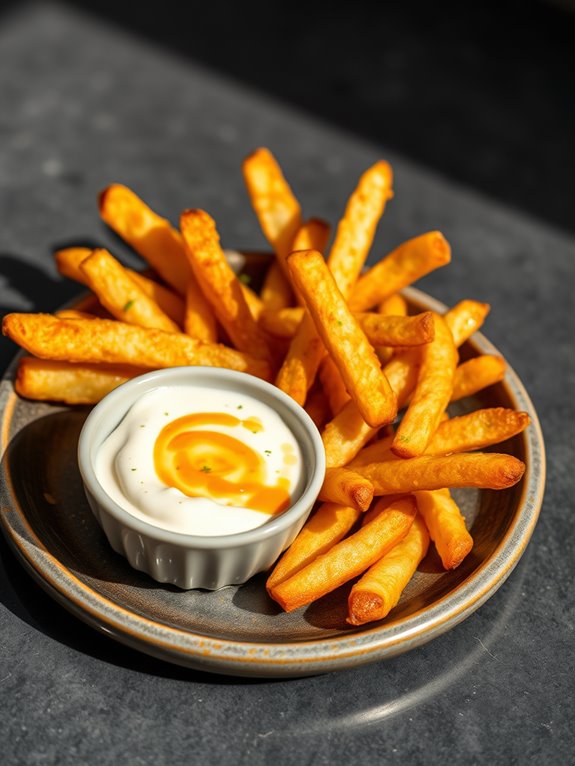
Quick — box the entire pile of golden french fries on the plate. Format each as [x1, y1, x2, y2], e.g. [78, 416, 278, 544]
[2, 149, 529, 625]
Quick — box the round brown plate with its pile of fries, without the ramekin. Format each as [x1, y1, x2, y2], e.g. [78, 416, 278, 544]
[0, 149, 545, 676]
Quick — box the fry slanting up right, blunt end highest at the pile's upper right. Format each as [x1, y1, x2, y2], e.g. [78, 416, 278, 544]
[349, 231, 451, 311]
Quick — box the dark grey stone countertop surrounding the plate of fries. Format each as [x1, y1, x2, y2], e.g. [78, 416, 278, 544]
[0, 4, 575, 764]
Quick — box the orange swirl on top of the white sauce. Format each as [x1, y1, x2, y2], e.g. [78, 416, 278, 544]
[154, 412, 290, 515]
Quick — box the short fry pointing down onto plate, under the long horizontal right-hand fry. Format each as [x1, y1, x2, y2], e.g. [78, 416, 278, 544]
[415, 489, 473, 569]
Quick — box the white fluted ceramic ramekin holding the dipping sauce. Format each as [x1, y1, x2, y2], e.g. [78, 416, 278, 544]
[78, 367, 325, 590]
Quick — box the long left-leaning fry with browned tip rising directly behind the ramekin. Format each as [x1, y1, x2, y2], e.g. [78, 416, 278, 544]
[180, 210, 271, 360]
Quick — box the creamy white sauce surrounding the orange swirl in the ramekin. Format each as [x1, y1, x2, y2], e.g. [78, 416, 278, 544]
[96, 386, 304, 535]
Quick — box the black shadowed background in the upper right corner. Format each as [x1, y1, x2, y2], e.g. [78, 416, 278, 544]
[5, 0, 575, 230]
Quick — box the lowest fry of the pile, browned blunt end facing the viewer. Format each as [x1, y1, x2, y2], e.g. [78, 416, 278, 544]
[347, 515, 429, 625]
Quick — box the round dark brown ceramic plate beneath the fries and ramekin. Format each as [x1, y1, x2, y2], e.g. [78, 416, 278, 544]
[0, 288, 545, 677]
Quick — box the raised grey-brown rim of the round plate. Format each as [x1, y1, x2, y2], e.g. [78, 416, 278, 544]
[0, 287, 546, 678]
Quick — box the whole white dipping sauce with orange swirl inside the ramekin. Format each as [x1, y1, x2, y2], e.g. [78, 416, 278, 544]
[96, 386, 304, 535]
